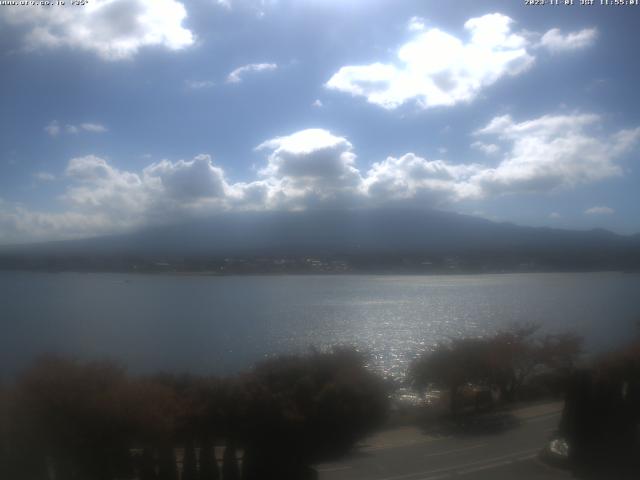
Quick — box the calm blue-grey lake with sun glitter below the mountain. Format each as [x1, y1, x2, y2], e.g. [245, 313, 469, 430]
[0, 272, 640, 376]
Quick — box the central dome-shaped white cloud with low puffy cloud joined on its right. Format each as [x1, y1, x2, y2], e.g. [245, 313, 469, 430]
[248, 129, 481, 209]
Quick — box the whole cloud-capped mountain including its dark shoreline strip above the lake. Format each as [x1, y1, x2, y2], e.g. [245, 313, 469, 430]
[0, 209, 640, 269]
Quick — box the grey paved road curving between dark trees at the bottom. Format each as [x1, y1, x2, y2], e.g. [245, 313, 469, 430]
[317, 404, 571, 480]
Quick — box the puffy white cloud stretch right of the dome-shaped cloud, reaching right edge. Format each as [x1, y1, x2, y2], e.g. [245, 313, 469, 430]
[363, 114, 640, 205]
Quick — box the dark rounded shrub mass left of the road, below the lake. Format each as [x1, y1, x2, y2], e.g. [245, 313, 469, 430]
[0, 350, 387, 480]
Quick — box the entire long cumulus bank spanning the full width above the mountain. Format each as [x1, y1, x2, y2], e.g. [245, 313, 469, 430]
[0, 113, 640, 240]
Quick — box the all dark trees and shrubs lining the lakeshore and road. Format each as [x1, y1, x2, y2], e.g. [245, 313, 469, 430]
[0, 325, 640, 480]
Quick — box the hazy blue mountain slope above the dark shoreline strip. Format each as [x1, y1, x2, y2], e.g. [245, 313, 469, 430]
[4, 209, 640, 256]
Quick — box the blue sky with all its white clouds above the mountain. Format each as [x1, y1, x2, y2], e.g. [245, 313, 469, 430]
[0, 0, 640, 244]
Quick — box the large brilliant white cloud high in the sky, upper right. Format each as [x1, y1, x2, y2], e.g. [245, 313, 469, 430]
[326, 13, 534, 109]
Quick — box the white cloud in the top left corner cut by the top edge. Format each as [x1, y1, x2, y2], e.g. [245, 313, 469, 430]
[0, 0, 194, 60]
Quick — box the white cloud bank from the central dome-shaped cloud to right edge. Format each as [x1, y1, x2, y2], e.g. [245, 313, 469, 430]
[240, 114, 640, 207]
